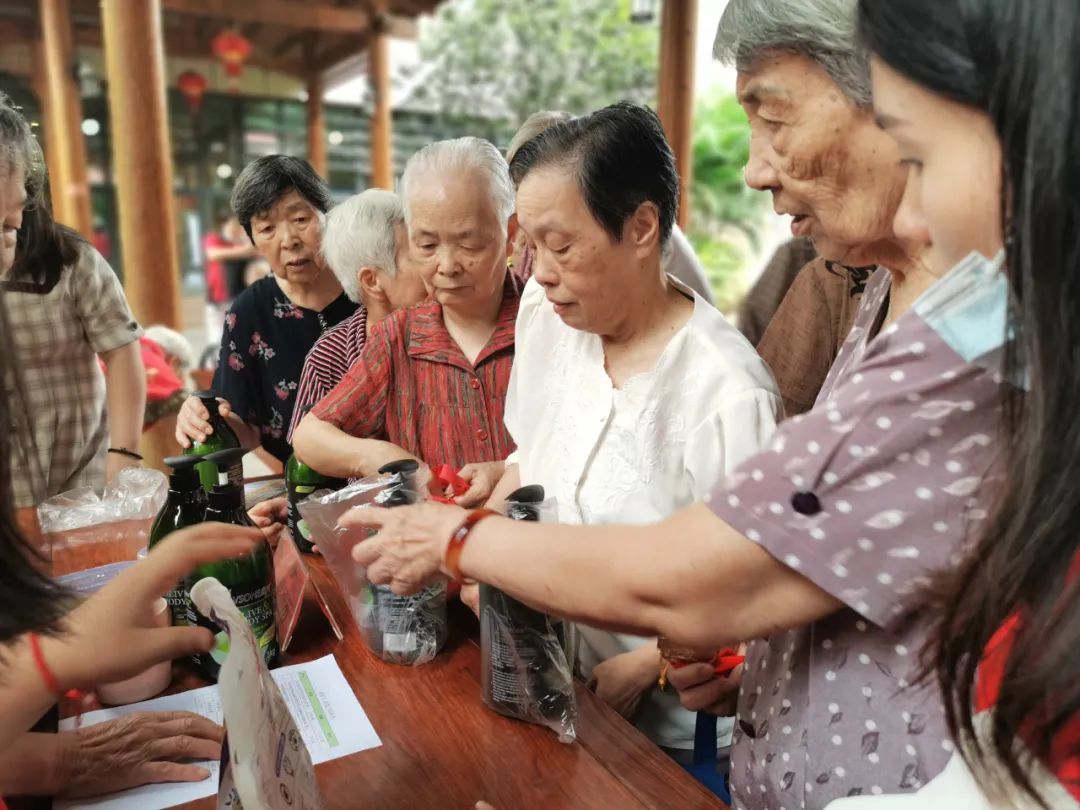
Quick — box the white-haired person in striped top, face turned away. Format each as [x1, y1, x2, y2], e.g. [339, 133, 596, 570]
[289, 189, 427, 440]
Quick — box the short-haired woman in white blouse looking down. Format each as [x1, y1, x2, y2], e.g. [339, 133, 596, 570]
[491, 105, 782, 750]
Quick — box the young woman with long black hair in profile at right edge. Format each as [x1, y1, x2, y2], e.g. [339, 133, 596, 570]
[839, 0, 1080, 808]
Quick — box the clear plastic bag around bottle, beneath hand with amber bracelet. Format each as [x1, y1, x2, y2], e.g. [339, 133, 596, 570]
[299, 474, 449, 666]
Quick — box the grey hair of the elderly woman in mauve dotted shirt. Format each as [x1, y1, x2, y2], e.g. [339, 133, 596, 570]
[713, 0, 873, 107]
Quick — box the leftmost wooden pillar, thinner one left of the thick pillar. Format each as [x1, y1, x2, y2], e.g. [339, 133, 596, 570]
[40, 0, 94, 237]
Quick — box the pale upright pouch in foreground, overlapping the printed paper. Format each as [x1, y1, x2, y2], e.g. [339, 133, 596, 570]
[191, 578, 323, 810]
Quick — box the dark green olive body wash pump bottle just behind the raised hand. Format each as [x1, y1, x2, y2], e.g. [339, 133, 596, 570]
[187, 448, 279, 680]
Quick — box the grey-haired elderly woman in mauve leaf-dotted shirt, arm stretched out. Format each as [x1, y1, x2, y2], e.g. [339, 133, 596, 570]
[345, 0, 1019, 809]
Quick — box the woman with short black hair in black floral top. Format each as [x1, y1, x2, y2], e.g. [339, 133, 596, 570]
[176, 154, 356, 463]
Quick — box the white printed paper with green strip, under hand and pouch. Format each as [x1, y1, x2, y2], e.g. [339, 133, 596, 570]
[53, 656, 382, 810]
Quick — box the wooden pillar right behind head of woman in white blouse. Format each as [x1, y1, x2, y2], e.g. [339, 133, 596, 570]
[659, 0, 698, 230]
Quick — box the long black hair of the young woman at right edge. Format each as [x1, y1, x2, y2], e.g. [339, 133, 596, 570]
[859, 0, 1080, 802]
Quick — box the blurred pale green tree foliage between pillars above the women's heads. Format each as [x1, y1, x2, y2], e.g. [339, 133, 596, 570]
[406, 0, 660, 145]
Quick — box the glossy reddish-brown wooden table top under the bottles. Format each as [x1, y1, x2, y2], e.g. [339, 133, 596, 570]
[48, 522, 726, 810]
